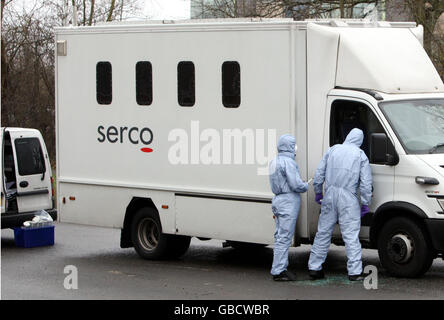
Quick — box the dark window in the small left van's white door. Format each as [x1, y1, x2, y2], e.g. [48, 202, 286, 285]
[14, 138, 46, 176]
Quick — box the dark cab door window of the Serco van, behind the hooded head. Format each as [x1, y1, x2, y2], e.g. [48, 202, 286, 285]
[330, 100, 385, 159]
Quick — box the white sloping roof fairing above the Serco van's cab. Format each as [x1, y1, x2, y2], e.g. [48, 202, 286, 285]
[307, 24, 444, 93]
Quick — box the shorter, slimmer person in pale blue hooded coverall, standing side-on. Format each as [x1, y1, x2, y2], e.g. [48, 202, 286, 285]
[270, 134, 308, 281]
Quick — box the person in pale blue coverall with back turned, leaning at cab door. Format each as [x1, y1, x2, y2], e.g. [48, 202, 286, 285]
[308, 128, 372, 281]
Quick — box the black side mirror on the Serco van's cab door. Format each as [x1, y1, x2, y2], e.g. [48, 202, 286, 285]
[370, 133, 399, 166]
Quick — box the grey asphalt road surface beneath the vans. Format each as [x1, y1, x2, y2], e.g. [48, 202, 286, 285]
[1, 223, 444, 300]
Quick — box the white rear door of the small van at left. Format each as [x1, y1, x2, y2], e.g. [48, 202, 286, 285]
[10, 130, 52, 213]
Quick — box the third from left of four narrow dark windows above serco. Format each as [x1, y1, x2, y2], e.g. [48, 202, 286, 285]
[177, 61, 195, 107]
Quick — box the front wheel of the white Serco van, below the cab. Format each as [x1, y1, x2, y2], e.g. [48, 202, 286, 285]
[378, 217, 433, 278]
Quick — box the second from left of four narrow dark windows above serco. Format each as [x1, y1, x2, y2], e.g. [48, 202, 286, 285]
[136, 61, 153, 106]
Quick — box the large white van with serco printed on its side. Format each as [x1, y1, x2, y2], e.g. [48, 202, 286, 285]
[56, 19, 444, 277]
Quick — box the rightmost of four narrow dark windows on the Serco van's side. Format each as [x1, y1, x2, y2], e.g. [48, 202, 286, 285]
[222, 61, 240, 108]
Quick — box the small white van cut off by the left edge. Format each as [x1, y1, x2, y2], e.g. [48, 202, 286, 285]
[0, 127, 57, 229]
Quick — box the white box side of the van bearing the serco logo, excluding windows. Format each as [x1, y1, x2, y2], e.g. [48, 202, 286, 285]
[57, 25, 298, 242]
